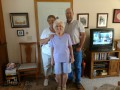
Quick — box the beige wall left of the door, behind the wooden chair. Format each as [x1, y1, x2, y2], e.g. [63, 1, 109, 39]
[2, 0, 36, 62]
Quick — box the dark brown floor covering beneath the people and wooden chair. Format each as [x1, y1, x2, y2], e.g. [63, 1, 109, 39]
[0, 77, 85, 90]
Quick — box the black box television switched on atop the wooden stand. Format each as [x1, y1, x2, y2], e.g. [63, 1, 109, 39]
[90, 28, 114, 52]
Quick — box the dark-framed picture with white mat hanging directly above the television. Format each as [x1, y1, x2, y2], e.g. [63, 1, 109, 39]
[97, 13, 108, 28]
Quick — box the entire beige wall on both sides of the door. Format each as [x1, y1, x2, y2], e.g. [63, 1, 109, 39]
[2, 0, 120, 62]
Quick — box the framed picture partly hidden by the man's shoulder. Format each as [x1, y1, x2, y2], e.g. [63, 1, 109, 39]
[77, 13, 89, 28]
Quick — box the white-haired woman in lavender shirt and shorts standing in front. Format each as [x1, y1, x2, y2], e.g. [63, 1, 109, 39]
[49, 20, 74, 90]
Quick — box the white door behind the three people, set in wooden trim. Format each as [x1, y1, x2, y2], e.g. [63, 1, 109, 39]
[37, 2, 70, 35]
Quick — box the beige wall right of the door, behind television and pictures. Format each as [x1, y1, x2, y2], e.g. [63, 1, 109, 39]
[73, 0, 120, 46]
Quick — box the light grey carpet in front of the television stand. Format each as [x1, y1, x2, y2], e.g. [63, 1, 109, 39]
[81, 76, 120, 90]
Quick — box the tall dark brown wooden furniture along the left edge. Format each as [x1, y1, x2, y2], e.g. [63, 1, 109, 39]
[0, 0, 8, 84]
